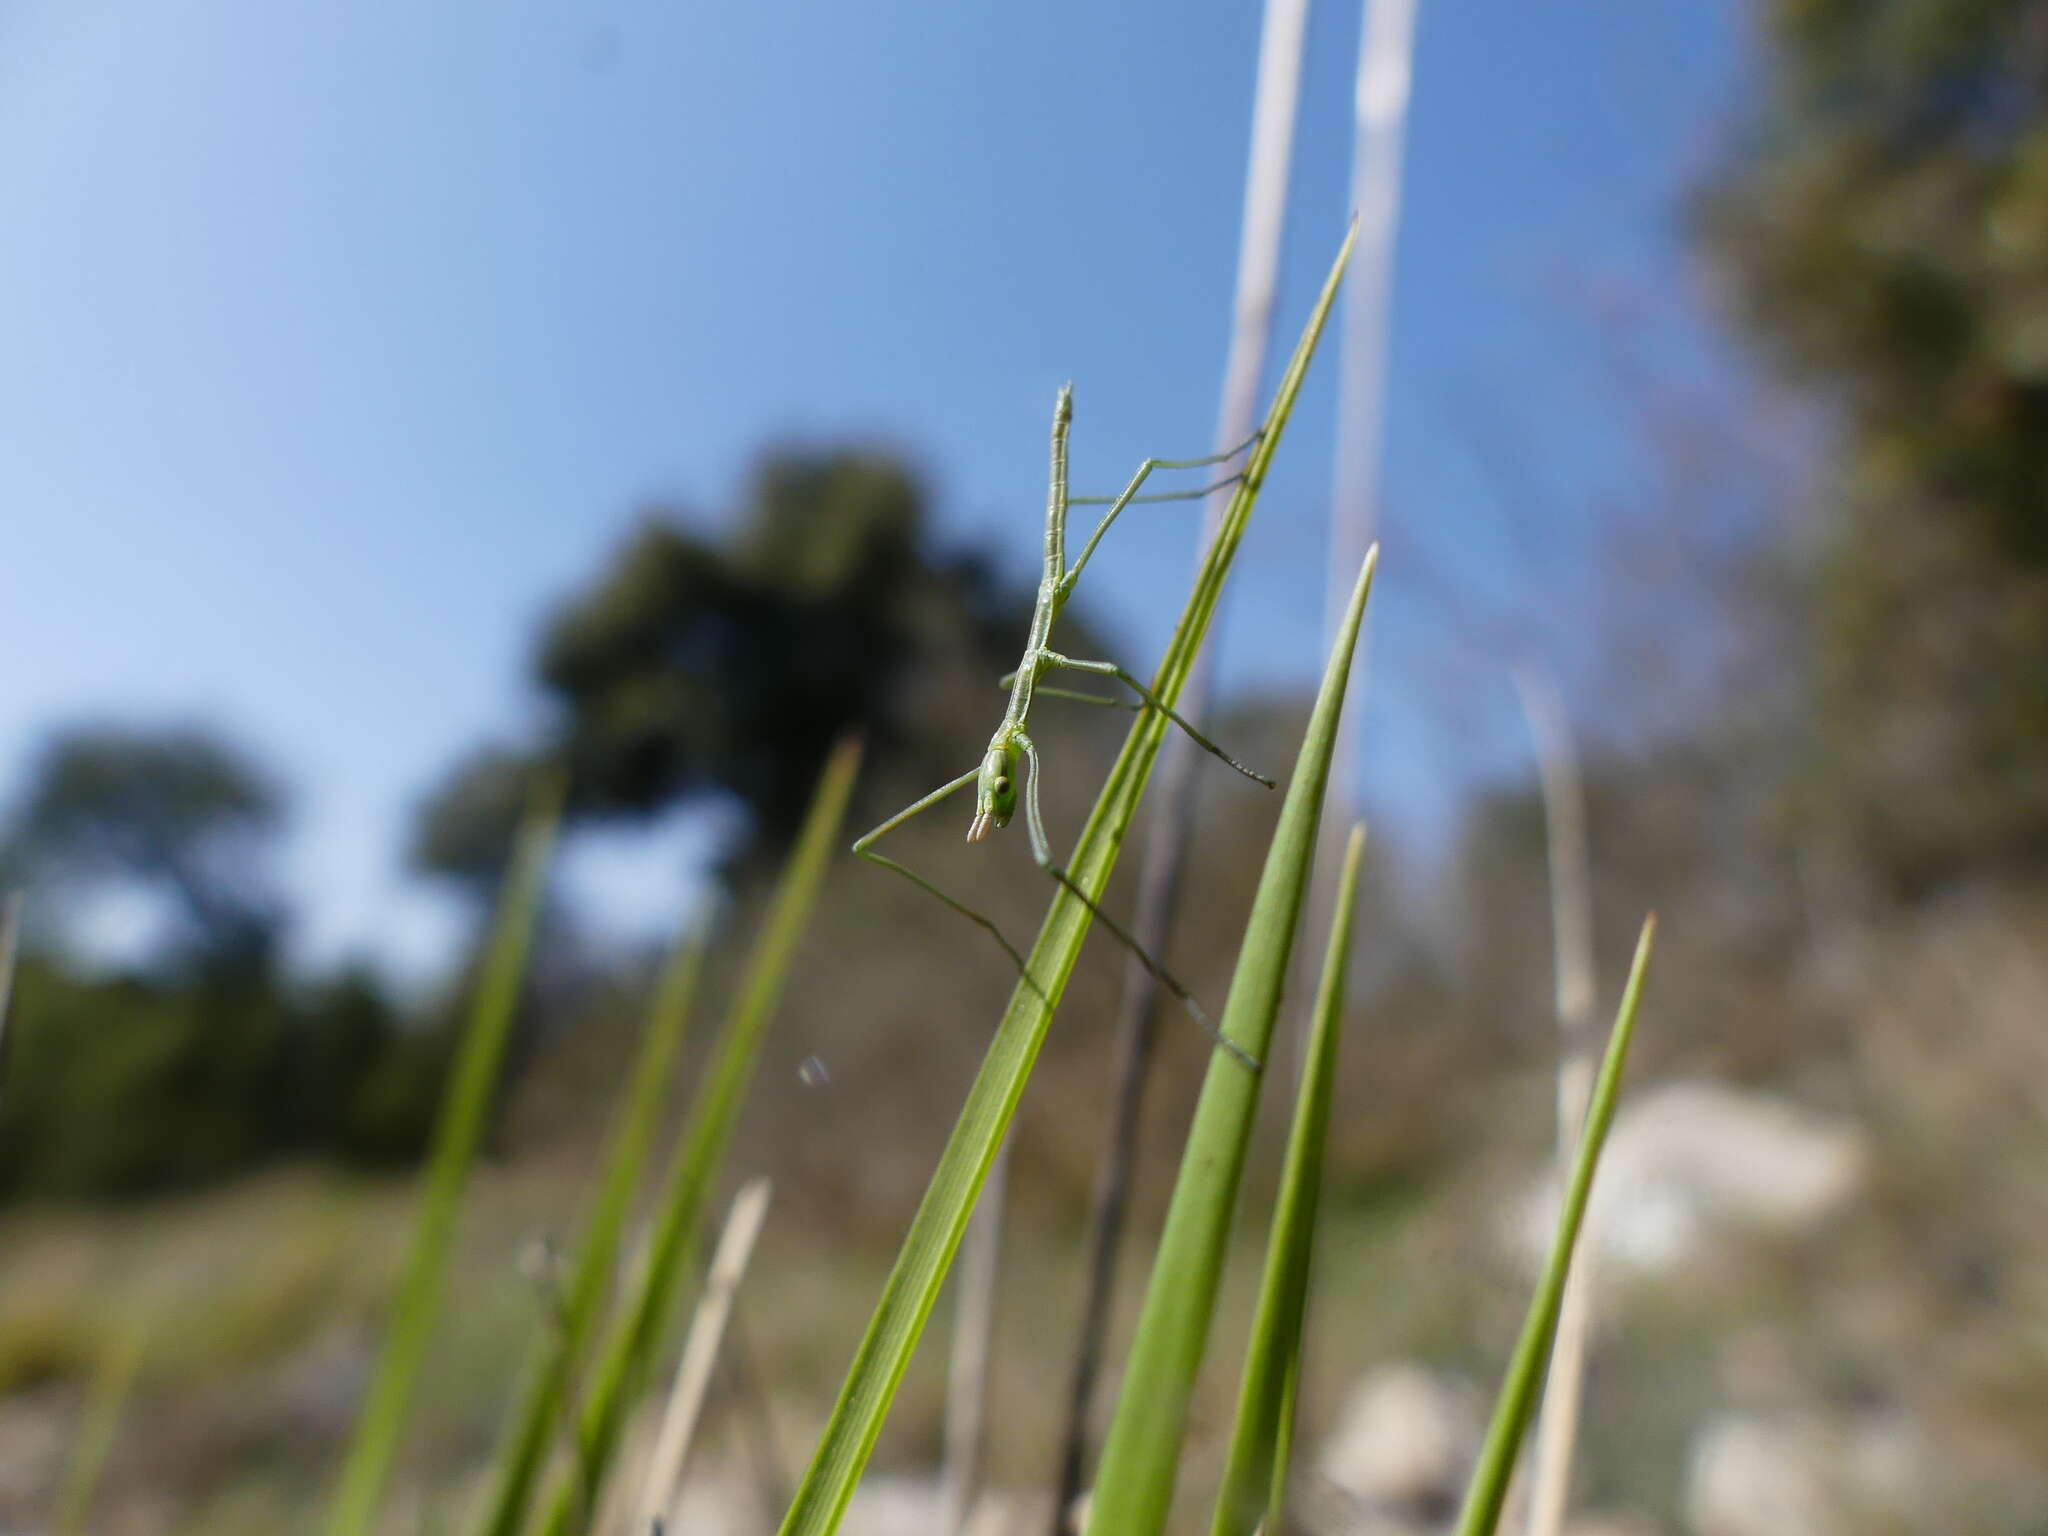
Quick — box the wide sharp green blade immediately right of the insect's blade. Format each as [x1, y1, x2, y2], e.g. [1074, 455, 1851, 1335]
[1087, 547, 1378, 1536]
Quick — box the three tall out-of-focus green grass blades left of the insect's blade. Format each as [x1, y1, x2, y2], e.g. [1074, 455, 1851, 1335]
[328, 739, 860, 1536]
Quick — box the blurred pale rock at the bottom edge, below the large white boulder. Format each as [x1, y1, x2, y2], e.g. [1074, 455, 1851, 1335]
[1686, 1413, 1937, 1536]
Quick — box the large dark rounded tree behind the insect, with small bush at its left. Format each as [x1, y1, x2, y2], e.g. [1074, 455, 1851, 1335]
[414, 451, 1028, 891]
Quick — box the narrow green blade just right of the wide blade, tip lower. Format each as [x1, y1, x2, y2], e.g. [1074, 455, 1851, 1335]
[1210, 825, 1366, 1536]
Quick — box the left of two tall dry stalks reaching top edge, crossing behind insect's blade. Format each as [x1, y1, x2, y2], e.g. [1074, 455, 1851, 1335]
[1051, 0, 1309, 1536]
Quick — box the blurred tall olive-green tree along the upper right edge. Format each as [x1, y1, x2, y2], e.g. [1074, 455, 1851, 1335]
[1702, 0, 2048, 895]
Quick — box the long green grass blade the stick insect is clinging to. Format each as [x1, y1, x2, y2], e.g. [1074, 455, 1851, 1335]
[782, 225, 1356, 1536]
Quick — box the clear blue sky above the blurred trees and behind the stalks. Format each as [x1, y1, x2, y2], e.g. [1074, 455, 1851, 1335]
[0, 0, 1743, 965]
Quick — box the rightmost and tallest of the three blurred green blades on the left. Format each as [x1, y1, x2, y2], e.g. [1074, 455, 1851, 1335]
[543, 737, 860, 1536]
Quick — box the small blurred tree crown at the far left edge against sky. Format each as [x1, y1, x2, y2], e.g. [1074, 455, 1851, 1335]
[6, 725, 283, 975]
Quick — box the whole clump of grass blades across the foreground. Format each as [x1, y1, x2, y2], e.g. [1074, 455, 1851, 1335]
[0, 225, 1679, 1536]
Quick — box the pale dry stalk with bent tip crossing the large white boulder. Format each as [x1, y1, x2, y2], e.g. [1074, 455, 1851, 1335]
[1516, 666, 1597, 1536]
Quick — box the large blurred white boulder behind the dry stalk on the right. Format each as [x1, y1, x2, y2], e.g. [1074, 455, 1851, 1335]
[1513, 1079, 1868, 1272]
